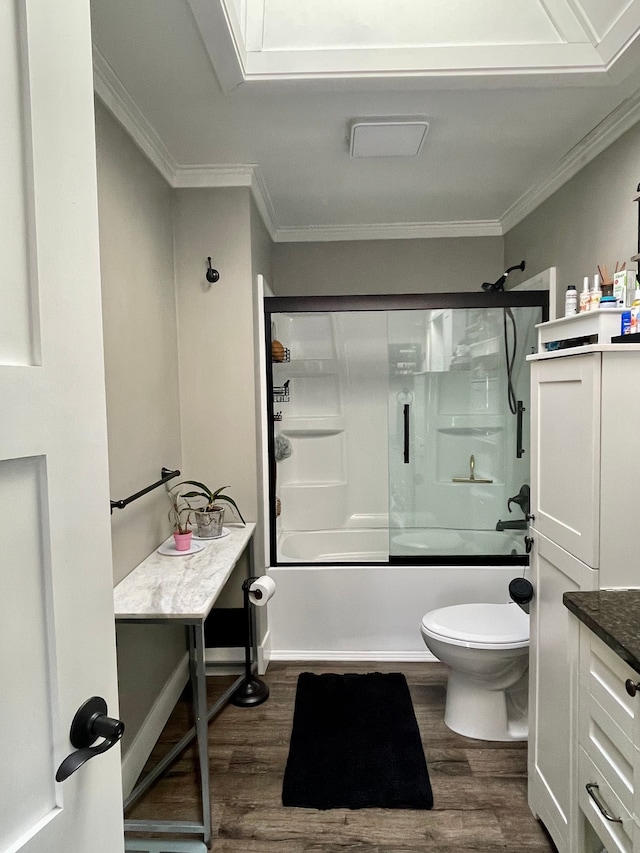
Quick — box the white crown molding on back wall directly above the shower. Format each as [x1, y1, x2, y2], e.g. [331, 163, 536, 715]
[275, 219, 502, 243]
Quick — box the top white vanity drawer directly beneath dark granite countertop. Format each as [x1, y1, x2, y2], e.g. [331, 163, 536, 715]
[580, 626, 640, 741]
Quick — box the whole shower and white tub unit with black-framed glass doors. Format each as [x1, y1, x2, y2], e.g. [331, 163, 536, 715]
[265, 291, 548, 660]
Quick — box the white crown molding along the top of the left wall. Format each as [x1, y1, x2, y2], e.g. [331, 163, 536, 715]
[93, 45, 178, 186]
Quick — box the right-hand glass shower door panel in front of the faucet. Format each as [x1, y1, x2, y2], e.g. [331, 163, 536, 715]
[388, 307, 540, 558]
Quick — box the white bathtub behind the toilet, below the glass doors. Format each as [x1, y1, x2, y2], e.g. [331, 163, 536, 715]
[266, 529, 528, 662]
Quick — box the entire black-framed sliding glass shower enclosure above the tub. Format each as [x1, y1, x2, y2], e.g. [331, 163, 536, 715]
[265, 293, 546, 564]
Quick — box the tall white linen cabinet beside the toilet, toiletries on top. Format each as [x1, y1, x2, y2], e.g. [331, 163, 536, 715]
[529, 345, 640, 853]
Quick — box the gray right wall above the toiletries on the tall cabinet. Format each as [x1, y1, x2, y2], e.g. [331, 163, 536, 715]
[505, 125, 640, 316]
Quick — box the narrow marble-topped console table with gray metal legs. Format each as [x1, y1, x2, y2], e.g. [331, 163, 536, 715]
[114, 524, 256, 847]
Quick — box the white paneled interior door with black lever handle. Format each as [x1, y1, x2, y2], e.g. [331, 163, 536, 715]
[0, 0, 123, 853]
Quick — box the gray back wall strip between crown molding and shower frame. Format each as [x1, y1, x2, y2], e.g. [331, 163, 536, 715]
[272, 237, 504, 296]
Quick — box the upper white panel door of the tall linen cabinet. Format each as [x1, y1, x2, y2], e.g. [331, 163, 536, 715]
[531, 353, 601, 568]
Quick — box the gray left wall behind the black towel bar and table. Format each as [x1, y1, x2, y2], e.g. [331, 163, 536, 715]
[96, 98, 185, 753]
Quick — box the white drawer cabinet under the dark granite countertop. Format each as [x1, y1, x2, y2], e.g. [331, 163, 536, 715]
[577, 625, 640, 853]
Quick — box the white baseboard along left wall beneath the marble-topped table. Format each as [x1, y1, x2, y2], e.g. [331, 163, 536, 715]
[122, 654, 189, 798]
